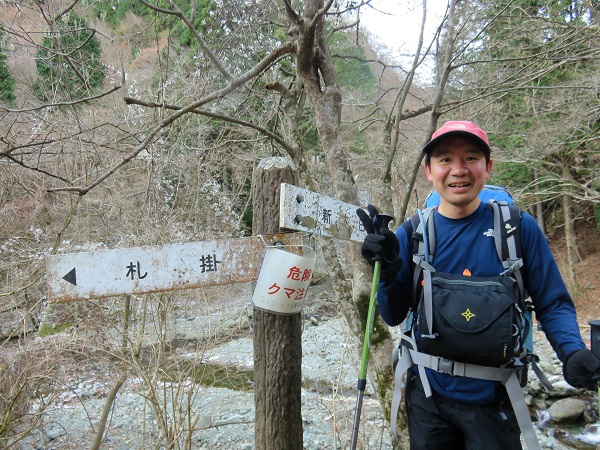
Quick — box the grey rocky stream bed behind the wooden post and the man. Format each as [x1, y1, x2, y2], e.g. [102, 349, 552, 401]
[4, 289, 600, 450]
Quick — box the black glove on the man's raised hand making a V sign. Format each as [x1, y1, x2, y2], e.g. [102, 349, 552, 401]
[356, 205, 402, 278]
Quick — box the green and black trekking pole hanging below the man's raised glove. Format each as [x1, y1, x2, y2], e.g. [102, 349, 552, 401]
[350, 214, 394, 450]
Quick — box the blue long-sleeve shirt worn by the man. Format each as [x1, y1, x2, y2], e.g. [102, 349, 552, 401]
[377, 202, 585, 404]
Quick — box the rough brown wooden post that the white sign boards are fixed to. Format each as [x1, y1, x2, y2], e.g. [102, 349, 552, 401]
[252, 158, 303, 450]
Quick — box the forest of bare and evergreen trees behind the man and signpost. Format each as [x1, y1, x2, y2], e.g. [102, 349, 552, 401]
[0, 0, 600, 448]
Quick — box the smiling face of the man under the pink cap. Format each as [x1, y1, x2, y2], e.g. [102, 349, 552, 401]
[425, 136, 492, 218]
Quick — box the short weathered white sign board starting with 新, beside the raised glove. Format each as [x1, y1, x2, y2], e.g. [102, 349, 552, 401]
[279, 183, 366, 242]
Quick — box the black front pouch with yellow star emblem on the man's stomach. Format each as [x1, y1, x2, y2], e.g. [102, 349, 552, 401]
[418, 271, 524, 367]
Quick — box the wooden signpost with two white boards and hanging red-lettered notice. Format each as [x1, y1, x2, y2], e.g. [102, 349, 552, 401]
[46, 158, 365, 450]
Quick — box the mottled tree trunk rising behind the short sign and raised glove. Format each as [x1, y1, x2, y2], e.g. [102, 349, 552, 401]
[287, 0, 406, 445]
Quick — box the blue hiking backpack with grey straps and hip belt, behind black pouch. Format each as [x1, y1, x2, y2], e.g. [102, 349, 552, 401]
[391, 185, 551, 449]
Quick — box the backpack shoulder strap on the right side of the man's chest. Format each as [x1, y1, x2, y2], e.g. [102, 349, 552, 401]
[490, 200, 526, 301]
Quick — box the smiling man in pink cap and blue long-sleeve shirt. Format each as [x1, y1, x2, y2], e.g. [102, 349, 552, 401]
[361, 121, 600, 450]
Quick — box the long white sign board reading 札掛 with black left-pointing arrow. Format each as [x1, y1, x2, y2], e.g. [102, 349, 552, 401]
[46, 233, 301, 302]
